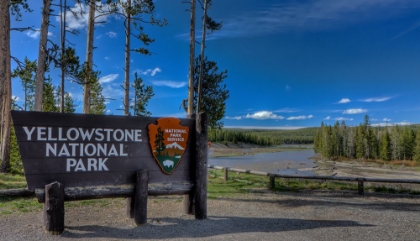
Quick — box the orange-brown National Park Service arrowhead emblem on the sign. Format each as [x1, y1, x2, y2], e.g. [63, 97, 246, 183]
[148, 118, 189, 175]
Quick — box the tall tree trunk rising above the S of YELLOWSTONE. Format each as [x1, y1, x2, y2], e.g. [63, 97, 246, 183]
[83, 0, 96, 114]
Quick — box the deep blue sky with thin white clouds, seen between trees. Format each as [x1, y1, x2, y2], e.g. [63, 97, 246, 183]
[11, 0, 420, 128]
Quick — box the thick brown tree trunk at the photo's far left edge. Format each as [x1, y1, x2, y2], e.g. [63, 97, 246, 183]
[0, 1, 12, 173]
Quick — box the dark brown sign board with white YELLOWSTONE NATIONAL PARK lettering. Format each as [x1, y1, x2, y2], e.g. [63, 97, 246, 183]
[12, 111, 195, 190]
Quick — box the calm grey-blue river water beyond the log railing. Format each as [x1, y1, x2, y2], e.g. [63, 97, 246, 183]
[209, 149, 316, 175]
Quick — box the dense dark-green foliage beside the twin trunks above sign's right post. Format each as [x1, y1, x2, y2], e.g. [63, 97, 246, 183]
[194, 56, 229, 129]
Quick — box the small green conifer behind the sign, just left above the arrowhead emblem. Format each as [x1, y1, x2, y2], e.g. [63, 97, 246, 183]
[131, 73, 155, 116]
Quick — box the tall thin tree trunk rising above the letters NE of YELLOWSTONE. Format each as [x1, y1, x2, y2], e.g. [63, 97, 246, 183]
[124, 0, 131, 116]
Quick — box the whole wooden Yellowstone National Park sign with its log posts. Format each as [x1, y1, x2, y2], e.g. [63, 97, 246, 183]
[12, 111, 207, 233]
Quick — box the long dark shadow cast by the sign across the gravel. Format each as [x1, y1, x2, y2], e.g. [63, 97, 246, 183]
[62, 216, 372, 239]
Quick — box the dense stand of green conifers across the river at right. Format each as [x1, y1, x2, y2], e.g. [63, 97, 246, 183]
[314, 116, 420, 161]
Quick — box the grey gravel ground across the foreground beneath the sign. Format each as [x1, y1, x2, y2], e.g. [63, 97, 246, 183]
[0, 192, 420, 241]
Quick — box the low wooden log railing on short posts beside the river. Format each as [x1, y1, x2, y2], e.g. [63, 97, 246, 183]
[207, 165, 420, 195]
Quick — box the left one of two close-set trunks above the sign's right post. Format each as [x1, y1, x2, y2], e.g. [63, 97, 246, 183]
[188, 0, 196, 115]
